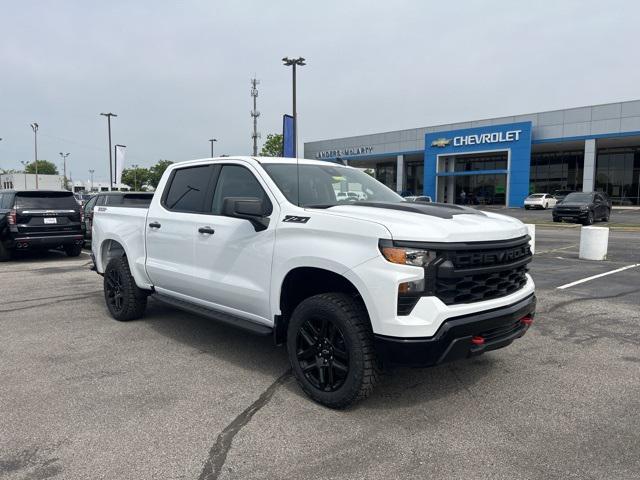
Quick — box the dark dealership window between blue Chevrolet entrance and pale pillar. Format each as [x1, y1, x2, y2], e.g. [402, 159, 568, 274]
[529, 150, 584, 193]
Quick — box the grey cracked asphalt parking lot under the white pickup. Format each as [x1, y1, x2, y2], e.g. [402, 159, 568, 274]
[0, 227, 640, 480]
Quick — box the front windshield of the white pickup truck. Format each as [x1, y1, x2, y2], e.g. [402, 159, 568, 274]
[263, 163, 403, 207]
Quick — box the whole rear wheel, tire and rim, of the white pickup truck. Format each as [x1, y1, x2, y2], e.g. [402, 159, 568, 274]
[103, 257, 147, 322]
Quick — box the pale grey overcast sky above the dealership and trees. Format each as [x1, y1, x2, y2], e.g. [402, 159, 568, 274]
[0, 0, 640, 180]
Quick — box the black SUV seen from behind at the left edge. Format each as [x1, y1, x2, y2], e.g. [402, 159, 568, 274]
[0, 190, 83, 261]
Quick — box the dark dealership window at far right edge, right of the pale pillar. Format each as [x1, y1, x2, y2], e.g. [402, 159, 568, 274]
[595, 146, 640, 205]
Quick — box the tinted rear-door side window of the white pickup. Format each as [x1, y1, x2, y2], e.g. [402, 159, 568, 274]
[162, 165, 213, 213]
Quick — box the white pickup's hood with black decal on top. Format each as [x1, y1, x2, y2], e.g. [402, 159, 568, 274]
[312, 202, 528, 242]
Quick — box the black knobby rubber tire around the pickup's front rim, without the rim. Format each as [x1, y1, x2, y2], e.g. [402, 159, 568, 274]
[287, 293, 381, 409]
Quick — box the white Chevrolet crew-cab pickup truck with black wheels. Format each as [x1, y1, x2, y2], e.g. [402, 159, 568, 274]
[92, 157, 535, 408]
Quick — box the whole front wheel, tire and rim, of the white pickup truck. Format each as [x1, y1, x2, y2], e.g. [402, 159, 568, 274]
[287, 293, 380, 408]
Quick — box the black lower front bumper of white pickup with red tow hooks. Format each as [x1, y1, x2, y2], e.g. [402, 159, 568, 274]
[375, 294, 536, 367]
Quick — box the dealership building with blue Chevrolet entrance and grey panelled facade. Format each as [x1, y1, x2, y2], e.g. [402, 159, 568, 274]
[304, 100, 640, 207]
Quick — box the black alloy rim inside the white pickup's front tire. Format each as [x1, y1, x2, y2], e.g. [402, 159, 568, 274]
[296, 318, 349, 392]
